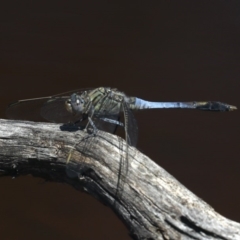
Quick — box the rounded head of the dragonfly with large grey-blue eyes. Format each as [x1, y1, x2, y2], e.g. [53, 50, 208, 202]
[65, 93, 84, 113]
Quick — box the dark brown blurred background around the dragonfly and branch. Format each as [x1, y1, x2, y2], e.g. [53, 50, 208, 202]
[0, 0, 240, 240]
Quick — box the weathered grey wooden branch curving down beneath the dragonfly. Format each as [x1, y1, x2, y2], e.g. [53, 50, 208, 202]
[0, 119, 240, 240]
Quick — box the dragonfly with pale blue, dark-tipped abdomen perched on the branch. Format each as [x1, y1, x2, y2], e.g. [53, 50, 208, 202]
[6, 87, 237, 199]
